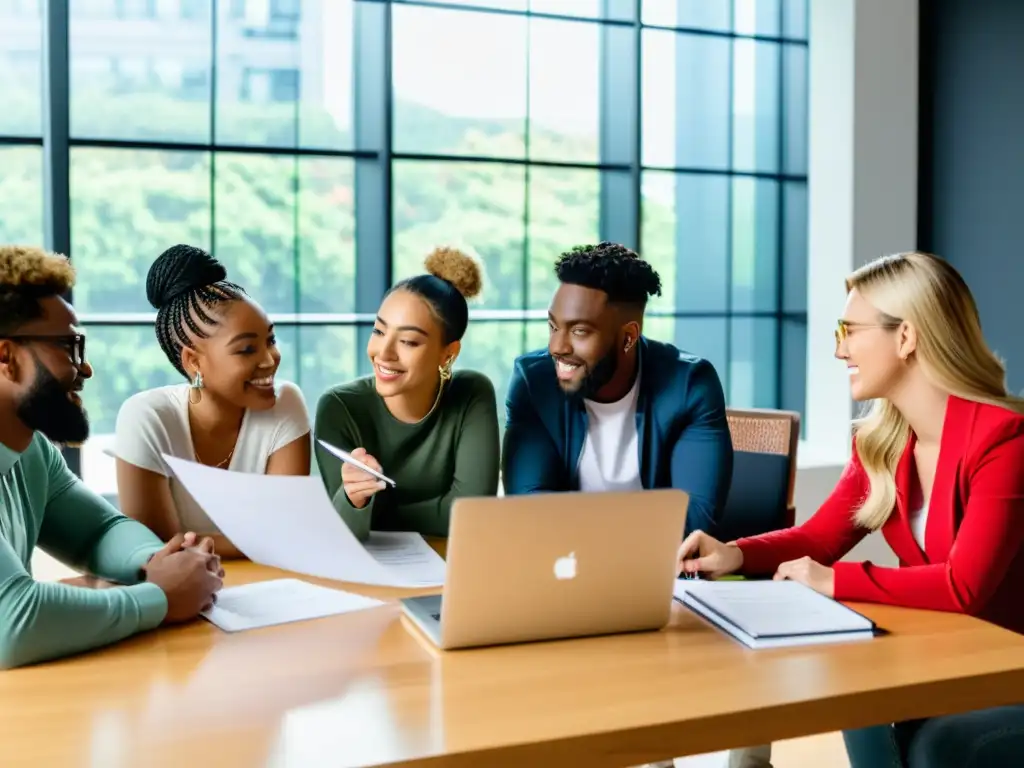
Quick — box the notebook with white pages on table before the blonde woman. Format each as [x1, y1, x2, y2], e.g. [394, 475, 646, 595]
[675, 579, 876, 648]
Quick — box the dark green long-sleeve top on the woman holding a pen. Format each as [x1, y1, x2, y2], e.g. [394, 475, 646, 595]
[315, 371, 501, 541]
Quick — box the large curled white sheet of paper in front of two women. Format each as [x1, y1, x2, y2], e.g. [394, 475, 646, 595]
[164, 454, 444, 587]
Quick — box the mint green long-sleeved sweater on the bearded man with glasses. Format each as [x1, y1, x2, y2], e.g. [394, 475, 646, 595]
[0, 433, 167, 668]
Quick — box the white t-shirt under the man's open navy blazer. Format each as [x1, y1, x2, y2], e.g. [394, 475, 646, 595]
[580, 374, 643, 492]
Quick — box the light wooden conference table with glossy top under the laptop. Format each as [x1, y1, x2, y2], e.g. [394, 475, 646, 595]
[6, 540, 1024, 768]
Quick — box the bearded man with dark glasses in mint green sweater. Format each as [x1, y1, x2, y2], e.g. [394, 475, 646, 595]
[0, 246, 223, 668]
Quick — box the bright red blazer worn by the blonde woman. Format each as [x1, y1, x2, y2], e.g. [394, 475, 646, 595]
[736, 396, 1024, 633]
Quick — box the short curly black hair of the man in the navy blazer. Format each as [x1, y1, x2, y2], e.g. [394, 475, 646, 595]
[555, 242, 662, 308]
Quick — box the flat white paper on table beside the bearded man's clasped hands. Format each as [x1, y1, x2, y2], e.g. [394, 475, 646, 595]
[203, 579, 384, 632]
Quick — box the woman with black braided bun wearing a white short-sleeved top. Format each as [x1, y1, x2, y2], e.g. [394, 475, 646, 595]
[115, 245, 311, 557]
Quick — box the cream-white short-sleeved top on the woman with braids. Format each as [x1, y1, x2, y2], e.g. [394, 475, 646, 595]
[114, 382, 309, 534]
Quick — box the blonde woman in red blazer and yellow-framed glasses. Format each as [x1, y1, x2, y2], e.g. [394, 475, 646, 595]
[679, 253, 1024, 768]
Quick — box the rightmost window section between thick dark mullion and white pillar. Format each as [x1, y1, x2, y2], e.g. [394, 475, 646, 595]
[641, 0, 807, 411]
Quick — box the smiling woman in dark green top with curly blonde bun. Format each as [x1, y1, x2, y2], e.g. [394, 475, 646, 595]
[315, 248, 500, 540]
